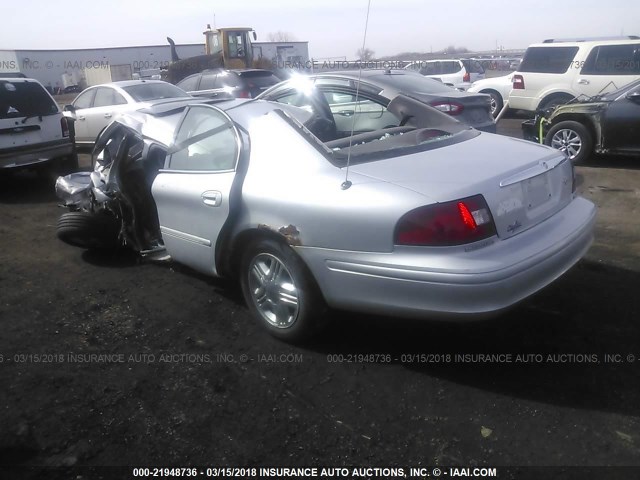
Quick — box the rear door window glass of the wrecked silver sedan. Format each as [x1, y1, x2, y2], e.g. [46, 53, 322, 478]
[168, 106, 238, 171]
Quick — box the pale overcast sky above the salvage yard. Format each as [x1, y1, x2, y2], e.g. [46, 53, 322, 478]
[0, 0, 640, 59]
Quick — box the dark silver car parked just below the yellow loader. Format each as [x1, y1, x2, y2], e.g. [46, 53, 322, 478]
[177, 68, 280, 99]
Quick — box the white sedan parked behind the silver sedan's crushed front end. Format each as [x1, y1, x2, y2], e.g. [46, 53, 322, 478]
[64, 80, 192, 146]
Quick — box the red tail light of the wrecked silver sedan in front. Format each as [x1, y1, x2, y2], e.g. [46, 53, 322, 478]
[394, 195, 496, 247]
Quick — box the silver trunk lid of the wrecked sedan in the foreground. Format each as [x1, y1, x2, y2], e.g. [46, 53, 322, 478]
[351, 134, 573, 238]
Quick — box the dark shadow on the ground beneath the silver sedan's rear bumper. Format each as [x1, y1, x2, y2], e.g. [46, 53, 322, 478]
[308, 261, 640, 416]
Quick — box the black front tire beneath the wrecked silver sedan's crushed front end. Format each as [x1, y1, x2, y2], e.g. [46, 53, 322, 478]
[56, 212, 120, 248]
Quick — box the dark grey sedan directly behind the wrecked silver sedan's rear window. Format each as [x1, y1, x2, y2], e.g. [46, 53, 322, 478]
[258, 70, 496, 133]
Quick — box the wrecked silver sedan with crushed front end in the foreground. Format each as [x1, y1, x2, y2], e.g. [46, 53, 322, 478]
[57, 95, 595, 341]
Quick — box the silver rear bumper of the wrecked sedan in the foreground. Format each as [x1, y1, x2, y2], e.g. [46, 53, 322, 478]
[296, 198, 596, 319]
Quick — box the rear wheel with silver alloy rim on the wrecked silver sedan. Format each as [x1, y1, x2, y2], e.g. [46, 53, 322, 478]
[240, 239, 328, 343]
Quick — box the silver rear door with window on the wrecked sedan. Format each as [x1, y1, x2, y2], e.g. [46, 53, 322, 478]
[152, 105, 241, 275]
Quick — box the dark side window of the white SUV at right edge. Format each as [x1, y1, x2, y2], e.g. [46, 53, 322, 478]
[581, 45, 640, 75]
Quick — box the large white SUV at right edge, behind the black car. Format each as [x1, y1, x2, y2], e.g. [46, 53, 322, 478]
[509, 36, 640, 111]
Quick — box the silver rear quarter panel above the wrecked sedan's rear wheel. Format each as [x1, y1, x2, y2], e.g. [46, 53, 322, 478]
[233, 112, 431, 252]
